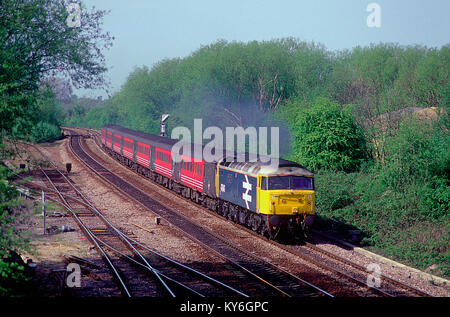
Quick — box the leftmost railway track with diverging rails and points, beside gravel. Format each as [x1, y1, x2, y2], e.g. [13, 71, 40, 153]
[29, 143, 248, 297]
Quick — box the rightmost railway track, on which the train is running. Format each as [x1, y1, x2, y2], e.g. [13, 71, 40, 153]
[76, 126, 432, 297]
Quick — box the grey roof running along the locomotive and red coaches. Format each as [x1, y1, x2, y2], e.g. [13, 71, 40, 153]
[103, 124, 314, 177]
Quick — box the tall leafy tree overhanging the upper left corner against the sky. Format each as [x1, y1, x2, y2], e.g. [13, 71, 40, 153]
[0, 0, 112, 132]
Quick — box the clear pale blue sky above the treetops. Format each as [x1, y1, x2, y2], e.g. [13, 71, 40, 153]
[75, 0, 450, 97]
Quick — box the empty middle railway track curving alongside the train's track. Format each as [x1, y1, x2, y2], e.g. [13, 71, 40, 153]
[66, 128, 332, 297]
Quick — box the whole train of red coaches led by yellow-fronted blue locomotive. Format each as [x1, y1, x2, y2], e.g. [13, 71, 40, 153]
[101, 125, 315, 239]
